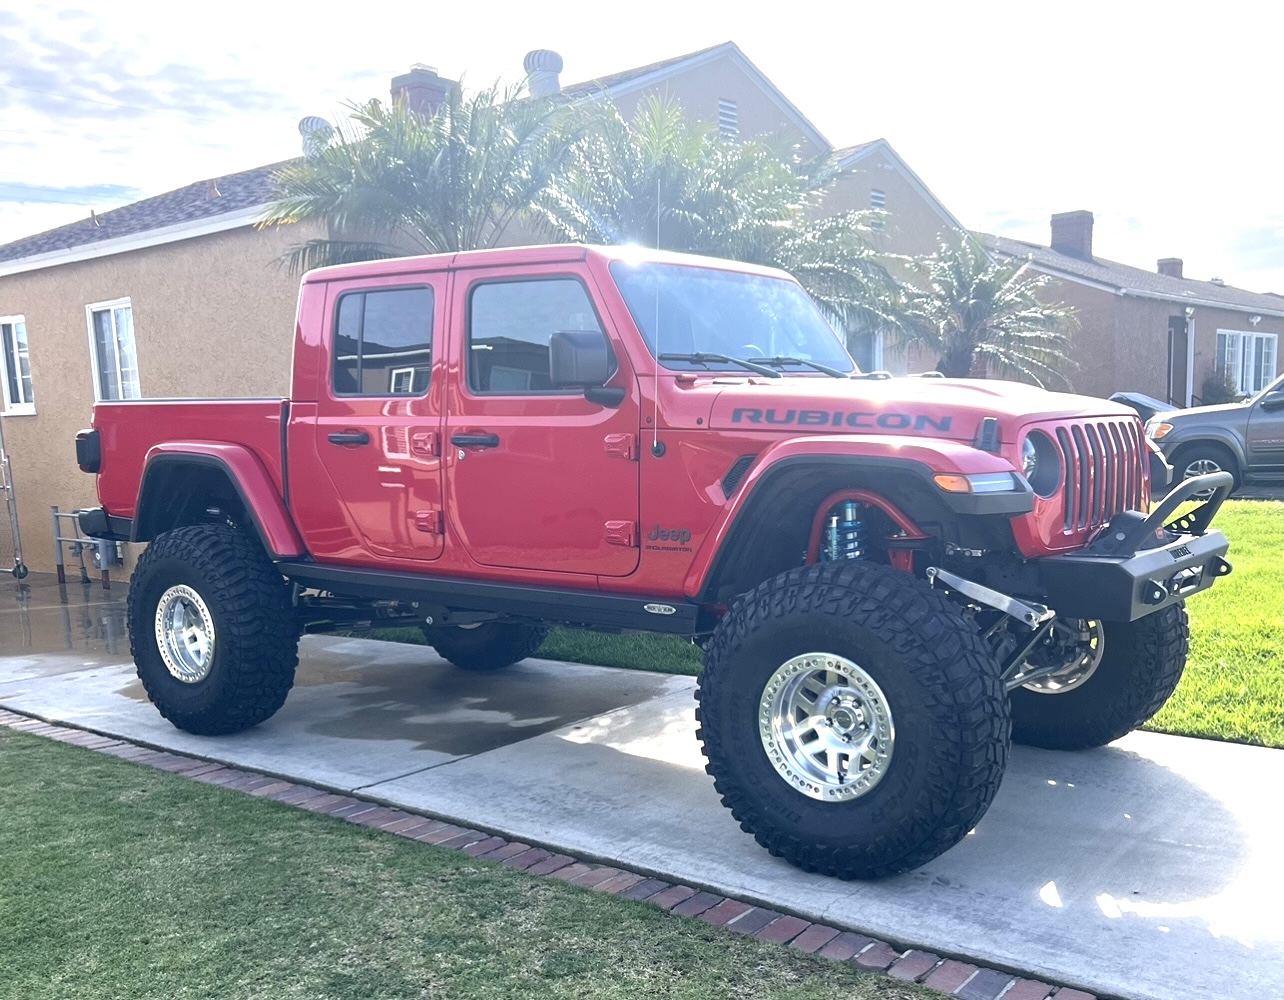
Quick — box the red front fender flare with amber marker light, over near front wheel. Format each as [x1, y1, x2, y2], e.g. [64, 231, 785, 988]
[683, 434, 1034, 601]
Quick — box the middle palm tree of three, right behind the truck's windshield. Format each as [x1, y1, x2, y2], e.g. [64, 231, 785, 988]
[537, 96, 891, 338]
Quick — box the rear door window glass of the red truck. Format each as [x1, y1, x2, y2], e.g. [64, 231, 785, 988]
[334, 288, 433, 395]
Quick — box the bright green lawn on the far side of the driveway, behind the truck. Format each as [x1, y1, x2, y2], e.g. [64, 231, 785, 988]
[371, 501, 1284, 747]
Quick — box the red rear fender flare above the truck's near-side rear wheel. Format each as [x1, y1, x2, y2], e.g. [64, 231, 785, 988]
[132, 442, 307, 558]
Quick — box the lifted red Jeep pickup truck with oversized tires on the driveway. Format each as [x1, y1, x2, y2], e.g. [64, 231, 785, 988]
[76, 246, 1230, 878]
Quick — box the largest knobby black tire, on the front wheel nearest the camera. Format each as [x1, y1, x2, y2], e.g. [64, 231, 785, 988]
[696, 562, 1009, 879]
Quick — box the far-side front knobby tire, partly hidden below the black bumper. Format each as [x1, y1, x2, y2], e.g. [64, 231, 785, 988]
[1012, 603, 1190, 750]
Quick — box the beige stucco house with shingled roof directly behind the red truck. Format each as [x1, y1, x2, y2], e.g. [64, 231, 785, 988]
[0, 42, 958, 571]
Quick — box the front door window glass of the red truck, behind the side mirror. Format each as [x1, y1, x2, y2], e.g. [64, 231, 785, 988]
[467, 277, 602, 395]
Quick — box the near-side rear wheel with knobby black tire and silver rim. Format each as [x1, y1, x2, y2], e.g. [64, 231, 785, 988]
[127, 525, 299, 736]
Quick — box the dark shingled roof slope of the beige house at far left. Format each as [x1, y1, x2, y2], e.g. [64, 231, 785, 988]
[0, 160, 294, 263]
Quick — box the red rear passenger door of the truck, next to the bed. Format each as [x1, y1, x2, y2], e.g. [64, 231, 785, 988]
[295, 275, 446, 565]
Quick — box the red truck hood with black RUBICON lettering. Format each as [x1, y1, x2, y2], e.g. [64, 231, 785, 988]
[693, 377, 1136, 443]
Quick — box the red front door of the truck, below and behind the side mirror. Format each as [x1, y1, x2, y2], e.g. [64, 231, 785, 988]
[443, 267, 639, 576]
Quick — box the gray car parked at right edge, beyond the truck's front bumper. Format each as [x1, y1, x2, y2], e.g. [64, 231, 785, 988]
[1145, 375, 1284, 489]
